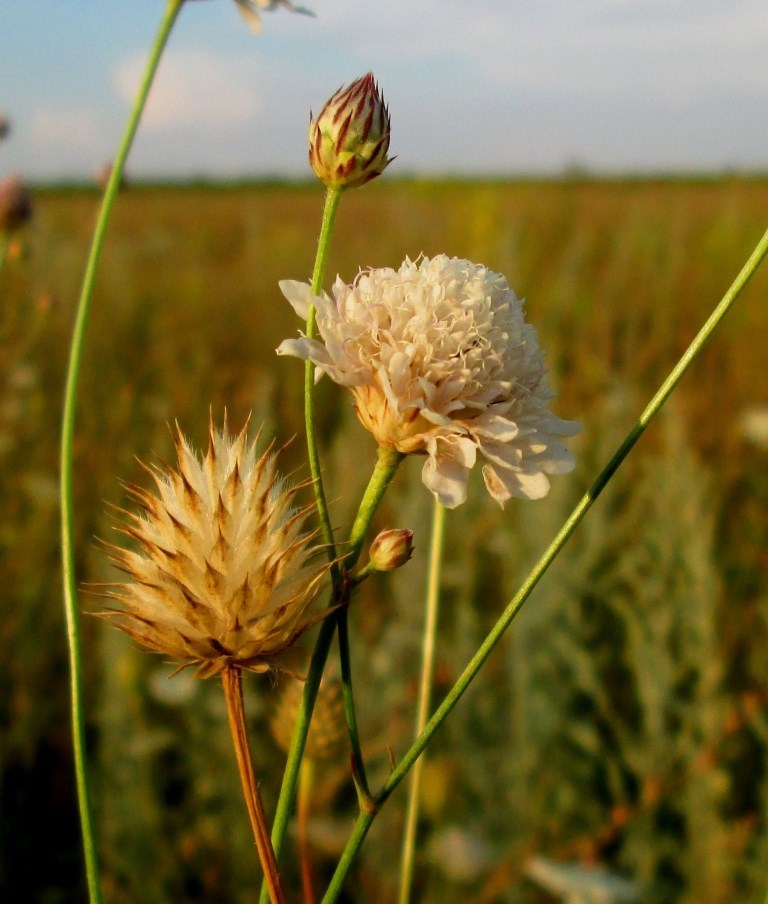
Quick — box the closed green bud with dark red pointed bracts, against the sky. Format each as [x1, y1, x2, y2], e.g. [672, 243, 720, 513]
[309, 72, 391, 188]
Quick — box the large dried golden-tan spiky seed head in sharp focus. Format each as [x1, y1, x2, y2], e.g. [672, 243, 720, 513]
[104, 423, 328, 677]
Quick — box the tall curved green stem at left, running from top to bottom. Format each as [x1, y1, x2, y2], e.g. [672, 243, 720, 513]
[60, 7, 183, 904]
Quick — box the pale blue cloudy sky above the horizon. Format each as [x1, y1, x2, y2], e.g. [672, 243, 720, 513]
[0, 0, 768, 180]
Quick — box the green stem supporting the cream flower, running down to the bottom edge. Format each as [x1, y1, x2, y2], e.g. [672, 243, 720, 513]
[260, 448, 405, 904]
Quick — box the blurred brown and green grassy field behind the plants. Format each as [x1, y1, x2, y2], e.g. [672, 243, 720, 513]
[0, 178, 768, 904]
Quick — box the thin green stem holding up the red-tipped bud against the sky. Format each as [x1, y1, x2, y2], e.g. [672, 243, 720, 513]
[304, 188, 341, 592]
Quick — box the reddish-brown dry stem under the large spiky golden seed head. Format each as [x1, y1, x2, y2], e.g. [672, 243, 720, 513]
[221, 666, 285, 904]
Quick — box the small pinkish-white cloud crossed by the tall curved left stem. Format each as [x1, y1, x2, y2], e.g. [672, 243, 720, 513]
[114, 50, 261, 131]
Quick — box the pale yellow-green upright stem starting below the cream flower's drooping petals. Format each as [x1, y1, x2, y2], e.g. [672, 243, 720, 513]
[398, 500, 445, 904]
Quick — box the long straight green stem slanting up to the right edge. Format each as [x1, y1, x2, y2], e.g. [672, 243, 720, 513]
[322, 230, 768, 904]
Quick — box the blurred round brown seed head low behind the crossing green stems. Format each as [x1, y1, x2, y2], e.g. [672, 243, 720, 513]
[269, 677, 347, 760]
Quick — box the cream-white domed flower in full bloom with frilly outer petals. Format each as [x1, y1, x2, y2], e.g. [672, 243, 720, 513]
[277, 255, 580, 508]
